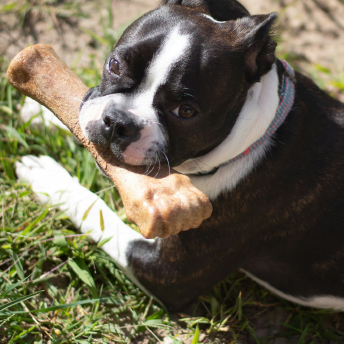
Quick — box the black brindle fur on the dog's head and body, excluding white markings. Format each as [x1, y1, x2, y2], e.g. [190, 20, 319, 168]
[81, 0, 344, 311]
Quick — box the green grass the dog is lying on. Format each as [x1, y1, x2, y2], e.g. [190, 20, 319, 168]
[0, 1, 344, 344]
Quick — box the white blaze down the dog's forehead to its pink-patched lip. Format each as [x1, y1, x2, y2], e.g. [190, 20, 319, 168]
[123, 27, 190, 164]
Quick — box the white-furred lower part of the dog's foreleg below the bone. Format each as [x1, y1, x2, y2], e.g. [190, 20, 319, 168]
[16, 156, 156, 294]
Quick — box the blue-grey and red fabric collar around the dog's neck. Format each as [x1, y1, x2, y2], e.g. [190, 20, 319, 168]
[196, 60, 296, 176]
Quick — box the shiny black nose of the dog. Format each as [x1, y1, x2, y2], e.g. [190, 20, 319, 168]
[101, 108, 141, 144]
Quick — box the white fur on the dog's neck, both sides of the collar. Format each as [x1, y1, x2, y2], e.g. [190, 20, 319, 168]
[175, 64, 294, 199]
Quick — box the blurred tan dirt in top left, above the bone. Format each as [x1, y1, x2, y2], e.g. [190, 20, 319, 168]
[0, 0, 159, 68]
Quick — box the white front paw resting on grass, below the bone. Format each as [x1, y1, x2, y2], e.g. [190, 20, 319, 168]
[16, 155, 78, 203]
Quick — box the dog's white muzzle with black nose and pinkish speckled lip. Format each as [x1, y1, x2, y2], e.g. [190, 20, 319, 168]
[79, 96, 167, 166]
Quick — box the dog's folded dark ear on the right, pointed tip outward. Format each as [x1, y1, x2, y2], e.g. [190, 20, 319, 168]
[234, 12, 277, 83]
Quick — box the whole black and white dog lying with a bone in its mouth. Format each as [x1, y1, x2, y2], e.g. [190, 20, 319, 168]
[17, 0, 344, 311]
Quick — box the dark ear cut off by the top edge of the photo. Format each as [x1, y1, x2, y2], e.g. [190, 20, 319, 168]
[163, 0, 250, 21]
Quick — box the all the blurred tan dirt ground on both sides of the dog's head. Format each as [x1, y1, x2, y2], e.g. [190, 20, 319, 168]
[0, 0, 344, 74]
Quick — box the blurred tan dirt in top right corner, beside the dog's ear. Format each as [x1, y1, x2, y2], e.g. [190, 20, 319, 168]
[241, 0, 344, 73]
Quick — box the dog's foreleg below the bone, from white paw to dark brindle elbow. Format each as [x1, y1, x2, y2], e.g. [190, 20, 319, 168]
[16, 156, 220, 311]
